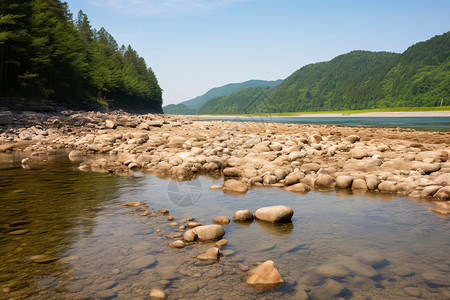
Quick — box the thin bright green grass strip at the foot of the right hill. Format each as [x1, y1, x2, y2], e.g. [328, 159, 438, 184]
[203, 106, 450, 117]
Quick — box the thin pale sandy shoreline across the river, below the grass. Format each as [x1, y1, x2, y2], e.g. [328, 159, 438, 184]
[196, 111, 450, 119]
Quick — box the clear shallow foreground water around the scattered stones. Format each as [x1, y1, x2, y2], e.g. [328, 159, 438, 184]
[0, 159, 450, 299]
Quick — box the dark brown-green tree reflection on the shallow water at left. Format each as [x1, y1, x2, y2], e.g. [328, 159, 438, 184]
[0, 159, 121, 298]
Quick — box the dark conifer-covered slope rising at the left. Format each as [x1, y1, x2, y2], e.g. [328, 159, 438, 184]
[0, 0, 162, 112]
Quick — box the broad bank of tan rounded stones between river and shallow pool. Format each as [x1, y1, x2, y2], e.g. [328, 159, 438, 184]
[0, 111, 450, 214]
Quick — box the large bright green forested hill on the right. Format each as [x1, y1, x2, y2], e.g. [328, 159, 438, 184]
[199, 32, 450, 114]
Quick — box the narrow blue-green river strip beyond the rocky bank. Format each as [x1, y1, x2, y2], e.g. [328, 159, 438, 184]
[207, 116, 450, 131]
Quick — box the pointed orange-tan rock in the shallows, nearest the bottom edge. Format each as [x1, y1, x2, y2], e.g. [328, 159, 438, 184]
[243, 260, 284, 289]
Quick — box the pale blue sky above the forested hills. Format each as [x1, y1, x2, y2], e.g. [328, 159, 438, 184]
[66, 0, 450, 105]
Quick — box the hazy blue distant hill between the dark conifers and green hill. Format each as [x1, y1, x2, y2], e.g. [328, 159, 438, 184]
[163, 79, 282, 115]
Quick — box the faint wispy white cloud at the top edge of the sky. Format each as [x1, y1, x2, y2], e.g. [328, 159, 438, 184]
[94, 0, 243, 15]
